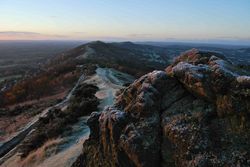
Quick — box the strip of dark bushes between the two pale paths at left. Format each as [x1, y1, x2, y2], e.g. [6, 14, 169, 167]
[19, 84, 99, 158]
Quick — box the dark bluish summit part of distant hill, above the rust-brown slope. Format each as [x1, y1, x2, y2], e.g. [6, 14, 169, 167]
[49, 41, 169, 76]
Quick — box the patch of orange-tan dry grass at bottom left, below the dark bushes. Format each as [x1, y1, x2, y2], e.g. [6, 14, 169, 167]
[20, 139, 62, 167]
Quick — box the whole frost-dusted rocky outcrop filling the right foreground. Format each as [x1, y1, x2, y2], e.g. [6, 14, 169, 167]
[73, 50, 250, 167]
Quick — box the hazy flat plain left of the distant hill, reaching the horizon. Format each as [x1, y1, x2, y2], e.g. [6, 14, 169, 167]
[0, 41, 83, 78]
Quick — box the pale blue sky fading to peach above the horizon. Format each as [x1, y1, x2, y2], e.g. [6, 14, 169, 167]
[0, 0, 250, 44]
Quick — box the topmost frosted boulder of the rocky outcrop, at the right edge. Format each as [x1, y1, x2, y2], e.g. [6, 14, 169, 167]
[166, 50, 250, 115]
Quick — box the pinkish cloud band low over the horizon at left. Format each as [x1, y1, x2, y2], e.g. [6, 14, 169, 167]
[0, 31, 68, 40]
